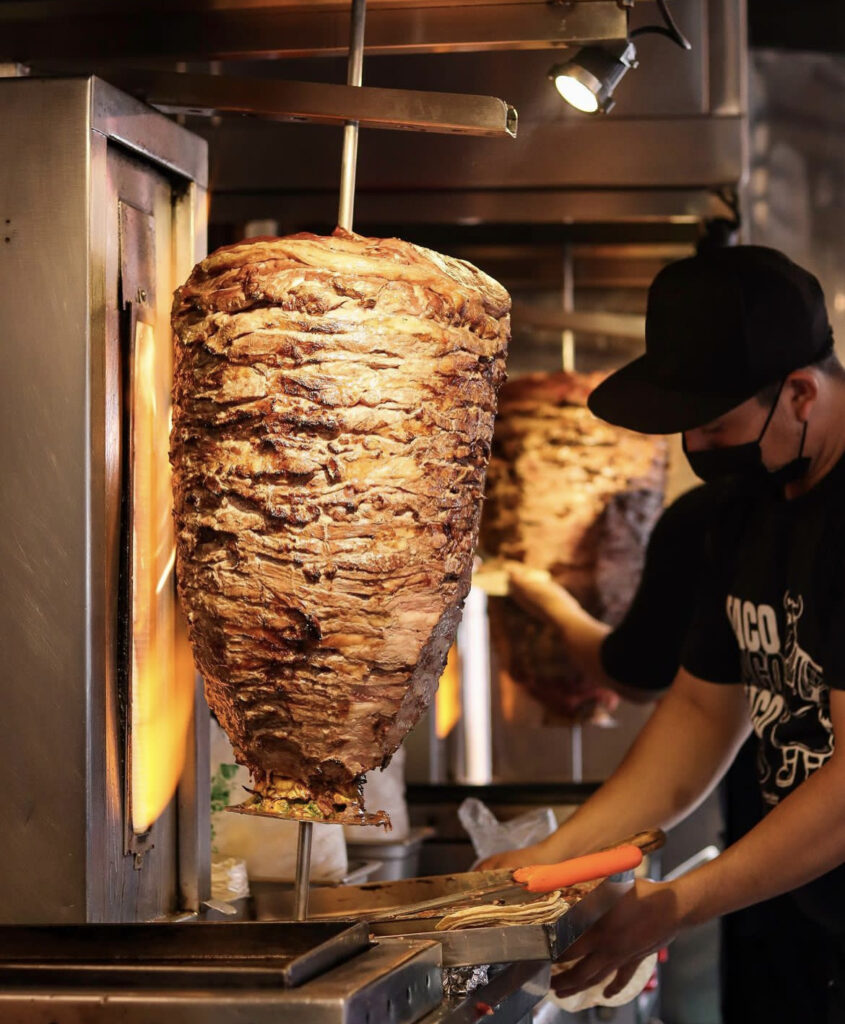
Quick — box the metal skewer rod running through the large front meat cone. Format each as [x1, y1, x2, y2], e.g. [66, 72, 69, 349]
[294, 0, 367, 921]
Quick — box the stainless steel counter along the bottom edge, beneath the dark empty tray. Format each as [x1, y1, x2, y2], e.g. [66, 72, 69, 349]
[0, 937, 550, 1024]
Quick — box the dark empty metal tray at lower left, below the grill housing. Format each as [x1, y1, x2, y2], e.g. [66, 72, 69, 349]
[0, 921, 370, 987]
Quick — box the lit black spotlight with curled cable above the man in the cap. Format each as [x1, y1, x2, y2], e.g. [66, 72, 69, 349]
[549, 0, 690, 114]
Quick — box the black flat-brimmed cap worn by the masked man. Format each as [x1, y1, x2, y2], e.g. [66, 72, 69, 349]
[588, 246, 833, 434]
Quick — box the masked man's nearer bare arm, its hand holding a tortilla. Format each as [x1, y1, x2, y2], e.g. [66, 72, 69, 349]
[555, 690, 845, 995]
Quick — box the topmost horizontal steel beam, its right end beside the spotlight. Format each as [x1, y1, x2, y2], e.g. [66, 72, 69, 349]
[0, 0, 625, 63]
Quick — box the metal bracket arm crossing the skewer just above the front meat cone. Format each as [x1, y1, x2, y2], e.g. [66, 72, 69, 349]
[110, 70, 517, 138]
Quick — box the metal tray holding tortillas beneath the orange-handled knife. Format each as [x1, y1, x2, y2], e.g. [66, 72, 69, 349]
[253, 871, 634, 967]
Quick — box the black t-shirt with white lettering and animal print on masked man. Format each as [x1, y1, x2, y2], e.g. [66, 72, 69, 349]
[681, 459, 845, 931]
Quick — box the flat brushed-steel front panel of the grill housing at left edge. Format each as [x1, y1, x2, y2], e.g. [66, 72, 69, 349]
[0, 79, 90, 922]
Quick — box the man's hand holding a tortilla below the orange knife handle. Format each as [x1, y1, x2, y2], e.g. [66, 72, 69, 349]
[552, 880, 680, 997]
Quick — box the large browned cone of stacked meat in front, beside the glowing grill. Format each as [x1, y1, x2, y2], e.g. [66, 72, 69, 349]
[171, 229, 503, 821]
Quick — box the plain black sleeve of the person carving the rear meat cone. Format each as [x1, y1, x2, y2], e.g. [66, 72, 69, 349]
[601, 482, 735, 690]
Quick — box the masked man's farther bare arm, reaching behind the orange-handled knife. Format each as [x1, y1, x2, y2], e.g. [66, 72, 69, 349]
[482, 669, 750, 868]
